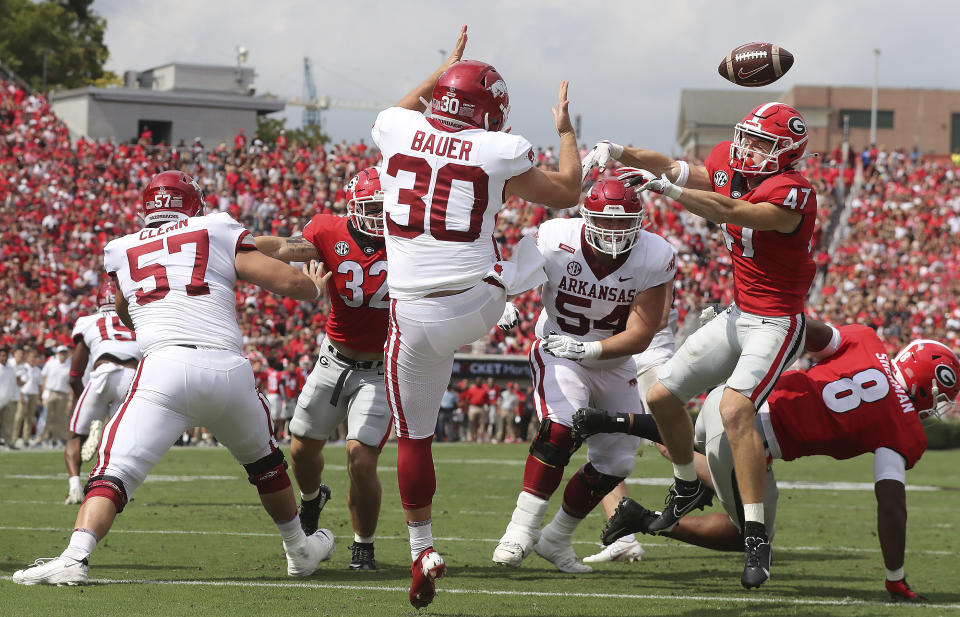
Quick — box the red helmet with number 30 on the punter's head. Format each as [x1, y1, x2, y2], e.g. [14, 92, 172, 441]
[429, 60, 510, 131]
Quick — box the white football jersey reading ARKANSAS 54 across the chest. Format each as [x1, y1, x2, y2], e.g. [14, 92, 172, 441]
[521, 218, 677, 368]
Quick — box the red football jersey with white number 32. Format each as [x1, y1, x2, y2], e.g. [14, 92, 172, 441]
[303, 214, 390, 352]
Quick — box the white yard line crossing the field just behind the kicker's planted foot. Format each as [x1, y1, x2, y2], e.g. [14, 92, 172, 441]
[0, 526, 956, 555]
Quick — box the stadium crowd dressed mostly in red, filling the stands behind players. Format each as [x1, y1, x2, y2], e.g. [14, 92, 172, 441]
[0, 82, 960, 442]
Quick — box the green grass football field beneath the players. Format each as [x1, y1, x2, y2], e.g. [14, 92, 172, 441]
[0, 444, 960, 617]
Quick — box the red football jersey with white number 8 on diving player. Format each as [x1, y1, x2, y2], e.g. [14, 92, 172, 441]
[768, 326, 927, 469]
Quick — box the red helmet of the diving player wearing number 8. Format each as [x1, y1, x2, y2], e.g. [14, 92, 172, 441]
[893, 339, 960, 420]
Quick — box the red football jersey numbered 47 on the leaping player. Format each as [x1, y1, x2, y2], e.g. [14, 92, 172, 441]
[704, 141, 817, 315]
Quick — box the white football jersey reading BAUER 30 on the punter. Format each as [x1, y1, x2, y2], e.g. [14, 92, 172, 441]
[372, 107, 534, 300]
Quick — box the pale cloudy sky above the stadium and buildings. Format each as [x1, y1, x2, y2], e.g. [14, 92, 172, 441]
[94, 0, 960, 153]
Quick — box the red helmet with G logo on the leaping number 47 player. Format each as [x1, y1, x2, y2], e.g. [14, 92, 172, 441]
[730, 103, 808, 178]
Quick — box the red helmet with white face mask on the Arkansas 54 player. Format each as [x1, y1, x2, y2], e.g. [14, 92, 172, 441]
[580, 178, 643, 257]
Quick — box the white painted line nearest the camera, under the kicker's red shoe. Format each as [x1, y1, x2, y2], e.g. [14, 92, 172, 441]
[0, 576, 960, 609]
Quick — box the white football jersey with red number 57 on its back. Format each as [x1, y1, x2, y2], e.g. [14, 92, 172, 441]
[103, 212, 256, 354]
